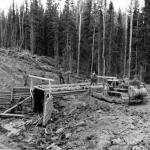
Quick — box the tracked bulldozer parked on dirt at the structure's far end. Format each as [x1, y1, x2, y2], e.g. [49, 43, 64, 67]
[92, 78, 147, 104]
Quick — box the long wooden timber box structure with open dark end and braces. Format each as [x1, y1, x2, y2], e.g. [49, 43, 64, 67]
[0, 75, 102, 126]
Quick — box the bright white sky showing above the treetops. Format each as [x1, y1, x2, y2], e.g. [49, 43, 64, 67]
[0, 0, 144, 12]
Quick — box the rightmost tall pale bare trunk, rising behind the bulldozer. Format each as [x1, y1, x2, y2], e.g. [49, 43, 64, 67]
[128, 0, 133, 79]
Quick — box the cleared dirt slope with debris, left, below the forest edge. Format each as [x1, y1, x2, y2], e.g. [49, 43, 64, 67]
[0, 49, 61, 90]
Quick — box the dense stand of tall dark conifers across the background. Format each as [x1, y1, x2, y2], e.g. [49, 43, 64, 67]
[0, 0, 150, 77]
